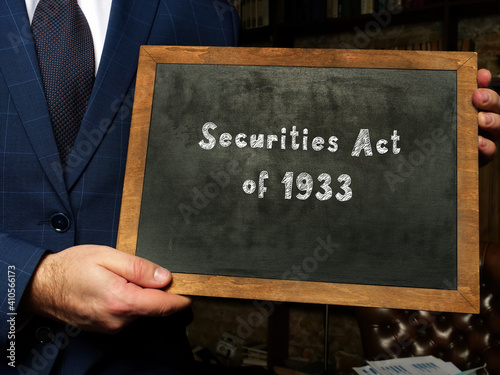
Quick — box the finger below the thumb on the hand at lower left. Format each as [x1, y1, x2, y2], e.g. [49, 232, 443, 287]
[122, 284, 192, 316]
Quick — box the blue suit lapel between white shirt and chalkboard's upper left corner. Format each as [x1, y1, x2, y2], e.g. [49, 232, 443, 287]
[65, 0, 159, 189]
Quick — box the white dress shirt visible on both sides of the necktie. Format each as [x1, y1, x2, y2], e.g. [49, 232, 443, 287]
[25, 0, 112, 72]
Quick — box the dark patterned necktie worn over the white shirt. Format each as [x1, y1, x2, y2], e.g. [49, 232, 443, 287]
[31, 0, 95, 165]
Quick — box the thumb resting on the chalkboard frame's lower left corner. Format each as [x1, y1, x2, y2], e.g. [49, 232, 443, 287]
[99, 249, 172, 288]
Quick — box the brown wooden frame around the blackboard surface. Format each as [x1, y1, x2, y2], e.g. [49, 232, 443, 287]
[117, 46, 479, 313]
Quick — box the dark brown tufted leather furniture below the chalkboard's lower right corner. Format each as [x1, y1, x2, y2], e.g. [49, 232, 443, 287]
[356, 244, 500, 374]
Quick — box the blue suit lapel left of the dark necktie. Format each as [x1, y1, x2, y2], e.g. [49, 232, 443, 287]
[0, 0, 69, 208]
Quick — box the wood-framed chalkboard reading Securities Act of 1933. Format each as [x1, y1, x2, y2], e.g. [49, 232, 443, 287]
[115, 47, 478, 311]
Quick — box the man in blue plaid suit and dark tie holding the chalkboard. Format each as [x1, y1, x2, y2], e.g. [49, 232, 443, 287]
[0, 0, 238, 375]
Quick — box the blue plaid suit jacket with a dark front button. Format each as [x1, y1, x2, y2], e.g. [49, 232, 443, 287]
[0, 0, 238, 374]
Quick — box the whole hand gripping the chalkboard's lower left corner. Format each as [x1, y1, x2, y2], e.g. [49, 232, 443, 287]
[21, 245, 191, 333]
